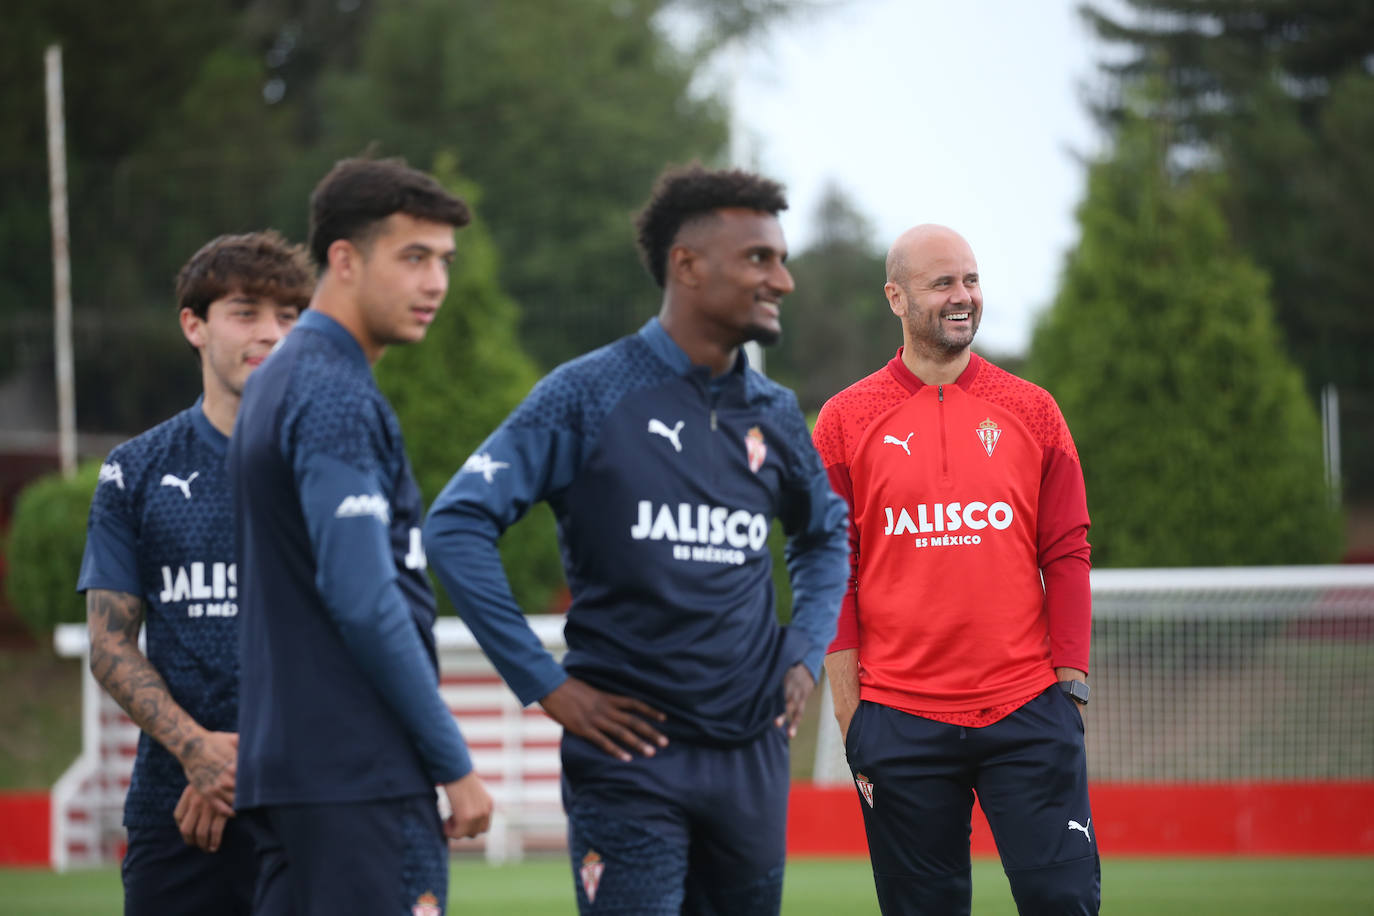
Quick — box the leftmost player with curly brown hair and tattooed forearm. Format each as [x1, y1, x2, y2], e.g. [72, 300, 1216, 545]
[77, 232, 315, 916]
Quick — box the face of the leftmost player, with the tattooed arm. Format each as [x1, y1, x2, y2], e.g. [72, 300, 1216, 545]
[181, 290, 301, 400]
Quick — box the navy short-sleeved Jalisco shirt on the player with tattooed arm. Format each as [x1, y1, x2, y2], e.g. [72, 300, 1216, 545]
[77, 398, 239, 827]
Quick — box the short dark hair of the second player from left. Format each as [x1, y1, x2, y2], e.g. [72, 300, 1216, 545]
[309, 158, 473, 271]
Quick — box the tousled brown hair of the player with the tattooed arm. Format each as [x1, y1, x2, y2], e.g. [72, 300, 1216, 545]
[176, 229, 315, 319]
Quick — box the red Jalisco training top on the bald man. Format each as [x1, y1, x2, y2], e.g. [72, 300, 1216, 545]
[815, 349, 1092, 725]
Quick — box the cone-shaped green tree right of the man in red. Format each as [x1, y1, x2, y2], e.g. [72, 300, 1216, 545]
[1028, 117, 1341, 567]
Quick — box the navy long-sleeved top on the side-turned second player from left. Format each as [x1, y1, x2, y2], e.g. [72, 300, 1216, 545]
[228, 310, 471, 809]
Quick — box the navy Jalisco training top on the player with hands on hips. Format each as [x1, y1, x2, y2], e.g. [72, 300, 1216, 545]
[425, 319, 849, 746]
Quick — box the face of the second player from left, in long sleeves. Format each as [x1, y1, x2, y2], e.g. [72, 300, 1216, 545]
[346, 213, 455, 361]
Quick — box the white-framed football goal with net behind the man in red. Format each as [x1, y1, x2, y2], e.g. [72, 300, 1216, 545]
[815, 566, 1374, 783]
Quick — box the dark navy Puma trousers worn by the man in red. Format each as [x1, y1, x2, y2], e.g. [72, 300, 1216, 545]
[845, 685, 1102, 916]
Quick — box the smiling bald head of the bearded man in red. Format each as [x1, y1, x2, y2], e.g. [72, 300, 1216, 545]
[883, 227, 982, 360]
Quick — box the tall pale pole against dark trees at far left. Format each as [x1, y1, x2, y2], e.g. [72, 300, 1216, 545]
[43, 44, 77, 478]
